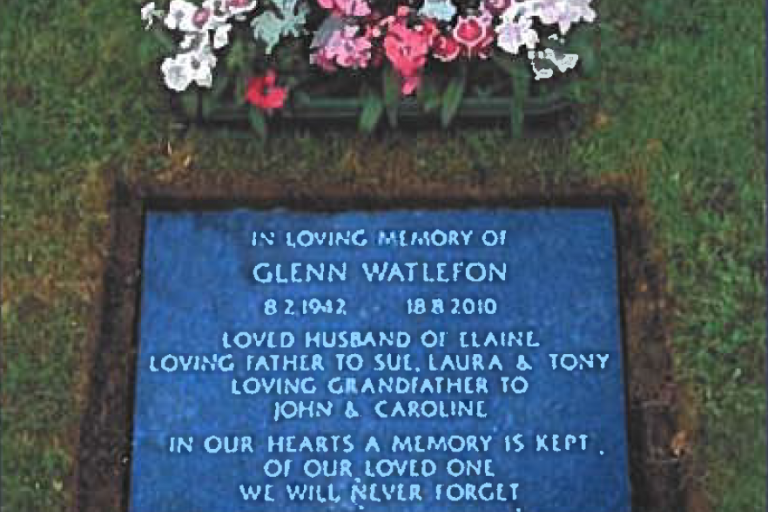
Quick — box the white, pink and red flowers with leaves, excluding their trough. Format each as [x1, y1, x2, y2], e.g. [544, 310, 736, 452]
[141, 0, 596, 133]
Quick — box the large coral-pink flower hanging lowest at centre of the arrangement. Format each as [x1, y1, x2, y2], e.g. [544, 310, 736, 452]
[384, 20, 431, 95]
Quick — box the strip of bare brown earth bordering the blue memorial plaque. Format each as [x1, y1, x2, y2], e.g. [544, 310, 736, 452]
[75, 180, 700, 512]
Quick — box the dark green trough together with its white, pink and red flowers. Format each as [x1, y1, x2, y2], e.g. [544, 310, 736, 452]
[142, 0, 596, 136]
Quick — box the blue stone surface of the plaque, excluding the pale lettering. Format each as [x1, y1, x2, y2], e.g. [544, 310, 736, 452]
[129, 209, 630, 512]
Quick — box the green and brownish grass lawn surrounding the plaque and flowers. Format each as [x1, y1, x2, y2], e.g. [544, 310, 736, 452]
[0, 0, 766, 512]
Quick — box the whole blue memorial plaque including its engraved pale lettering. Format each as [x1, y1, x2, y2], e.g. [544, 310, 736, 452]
[129, 208, 631, 512]
